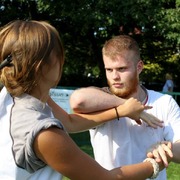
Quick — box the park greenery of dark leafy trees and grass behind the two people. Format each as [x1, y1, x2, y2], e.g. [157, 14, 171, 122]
[0, 0, 180, 180]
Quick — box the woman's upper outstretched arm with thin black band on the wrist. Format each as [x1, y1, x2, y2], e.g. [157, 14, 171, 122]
[48, 98, 162, 133]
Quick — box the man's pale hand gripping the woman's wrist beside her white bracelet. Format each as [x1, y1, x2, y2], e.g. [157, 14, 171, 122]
[147, 141, 173, 167]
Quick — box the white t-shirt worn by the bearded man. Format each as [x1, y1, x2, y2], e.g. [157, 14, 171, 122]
[90, 90, 180, 180]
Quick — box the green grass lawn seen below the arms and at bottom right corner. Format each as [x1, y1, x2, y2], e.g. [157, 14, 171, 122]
[63, 132, 180, 180]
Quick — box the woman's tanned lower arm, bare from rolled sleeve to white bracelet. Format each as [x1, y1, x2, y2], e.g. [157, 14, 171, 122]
[34, 127, 163, 180]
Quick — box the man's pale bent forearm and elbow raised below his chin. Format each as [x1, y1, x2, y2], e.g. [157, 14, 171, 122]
[70, 87, 125, 113]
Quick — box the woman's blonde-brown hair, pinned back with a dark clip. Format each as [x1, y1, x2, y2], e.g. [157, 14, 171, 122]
[0, 20, 64, 96]
